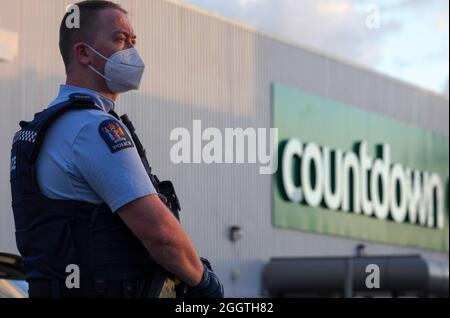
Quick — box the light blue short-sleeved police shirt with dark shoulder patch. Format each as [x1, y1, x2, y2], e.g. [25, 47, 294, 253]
[36, 85, 156, 212]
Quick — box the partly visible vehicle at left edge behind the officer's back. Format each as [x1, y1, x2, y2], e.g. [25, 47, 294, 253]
[0, 253, 28, 298]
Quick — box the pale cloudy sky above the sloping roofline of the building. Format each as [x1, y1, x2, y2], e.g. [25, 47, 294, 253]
[183, 0, 449, 97]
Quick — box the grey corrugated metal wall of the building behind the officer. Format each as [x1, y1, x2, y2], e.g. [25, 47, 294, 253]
[0, 0, 449, 296]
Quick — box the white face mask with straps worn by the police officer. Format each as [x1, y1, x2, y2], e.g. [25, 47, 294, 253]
[85, 43, 145, 93]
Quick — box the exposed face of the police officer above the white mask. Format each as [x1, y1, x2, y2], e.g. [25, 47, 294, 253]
[88, 9, 136, 87]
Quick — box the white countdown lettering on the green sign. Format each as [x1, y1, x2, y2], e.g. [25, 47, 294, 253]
[281, 138, 445, 229]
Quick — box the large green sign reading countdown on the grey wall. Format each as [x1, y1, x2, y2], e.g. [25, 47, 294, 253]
[272, 84, 449, 251]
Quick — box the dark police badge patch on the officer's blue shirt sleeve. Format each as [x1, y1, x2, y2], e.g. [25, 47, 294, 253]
[98, 119, 134, 153]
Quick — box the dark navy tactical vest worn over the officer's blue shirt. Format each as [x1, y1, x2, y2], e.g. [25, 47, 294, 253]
[10, 94, 156, 281]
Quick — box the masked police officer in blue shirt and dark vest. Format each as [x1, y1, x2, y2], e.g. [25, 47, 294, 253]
[11, 1, 223, 297]
